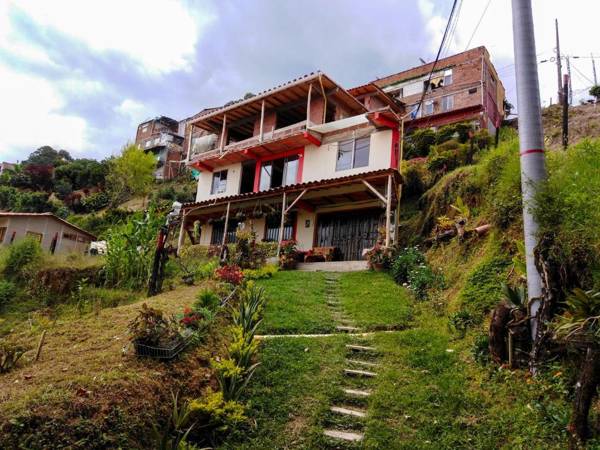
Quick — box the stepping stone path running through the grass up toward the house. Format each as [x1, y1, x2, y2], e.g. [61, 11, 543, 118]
[323, 273, 378, 448]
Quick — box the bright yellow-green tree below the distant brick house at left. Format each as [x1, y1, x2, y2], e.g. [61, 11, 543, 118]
[106, 144, 156, 204]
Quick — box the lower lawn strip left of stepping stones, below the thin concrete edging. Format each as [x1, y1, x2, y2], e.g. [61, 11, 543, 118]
[221, 336, 349, 450]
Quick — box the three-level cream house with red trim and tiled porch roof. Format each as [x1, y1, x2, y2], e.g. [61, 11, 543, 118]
[180, 72, 405, 260]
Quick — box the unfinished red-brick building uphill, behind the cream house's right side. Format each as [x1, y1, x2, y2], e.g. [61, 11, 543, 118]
[373, 47, 505, 136]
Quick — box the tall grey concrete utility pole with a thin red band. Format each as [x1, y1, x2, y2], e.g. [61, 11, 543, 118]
[512, 0, 546, 345]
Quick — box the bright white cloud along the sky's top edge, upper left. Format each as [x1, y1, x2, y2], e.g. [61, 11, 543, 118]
[6, 0, 214, 74]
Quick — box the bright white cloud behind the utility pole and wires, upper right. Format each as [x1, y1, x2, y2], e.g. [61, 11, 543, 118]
[418, 0, 600, 104]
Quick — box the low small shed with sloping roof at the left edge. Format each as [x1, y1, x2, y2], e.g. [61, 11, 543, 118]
[0, 211, 96, 253]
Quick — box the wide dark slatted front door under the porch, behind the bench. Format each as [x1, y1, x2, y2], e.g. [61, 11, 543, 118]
[316, 209, 382, 261]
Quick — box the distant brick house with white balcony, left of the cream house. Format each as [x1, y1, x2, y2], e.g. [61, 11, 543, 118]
[135, 116, 185, 180]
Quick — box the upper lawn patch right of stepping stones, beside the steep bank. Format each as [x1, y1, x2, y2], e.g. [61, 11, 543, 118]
[338, 272, 413, 330]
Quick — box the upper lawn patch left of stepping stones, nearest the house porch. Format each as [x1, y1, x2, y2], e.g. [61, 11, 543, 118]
[258, 272, 335, 334]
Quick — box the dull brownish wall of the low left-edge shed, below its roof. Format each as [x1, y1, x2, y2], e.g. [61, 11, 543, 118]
[0, 216, 90, 253]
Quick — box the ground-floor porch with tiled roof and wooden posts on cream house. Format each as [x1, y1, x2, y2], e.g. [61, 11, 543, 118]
[179, 169, 400, 261]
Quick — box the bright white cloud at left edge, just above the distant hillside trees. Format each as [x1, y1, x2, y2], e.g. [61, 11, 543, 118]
[0, 65, 86, 161]
